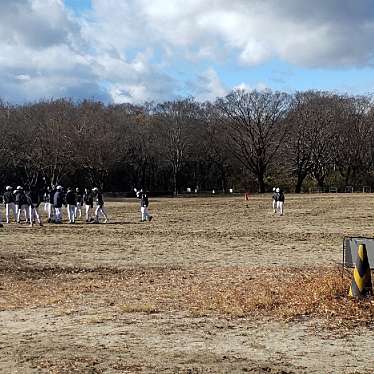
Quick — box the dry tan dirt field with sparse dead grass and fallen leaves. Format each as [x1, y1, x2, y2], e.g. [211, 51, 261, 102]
[0, 194, 374, 373]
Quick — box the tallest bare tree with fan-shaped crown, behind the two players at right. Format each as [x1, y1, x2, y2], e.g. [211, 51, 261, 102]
[216, 90, 290, 192]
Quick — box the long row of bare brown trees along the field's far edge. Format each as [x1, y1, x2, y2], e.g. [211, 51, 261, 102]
[0, 90, 374, 194]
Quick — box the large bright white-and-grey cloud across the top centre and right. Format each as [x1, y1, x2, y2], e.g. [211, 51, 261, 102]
[80, 0, 374, 76]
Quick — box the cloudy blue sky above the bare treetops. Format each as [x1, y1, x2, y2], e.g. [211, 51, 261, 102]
[0, 0, 374, 104]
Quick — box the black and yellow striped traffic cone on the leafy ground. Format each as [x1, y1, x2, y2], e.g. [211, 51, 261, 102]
[349, 244, 373, 298]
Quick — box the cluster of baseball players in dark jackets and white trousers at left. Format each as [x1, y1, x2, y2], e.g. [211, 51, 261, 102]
[0, 185, 108, 227]
